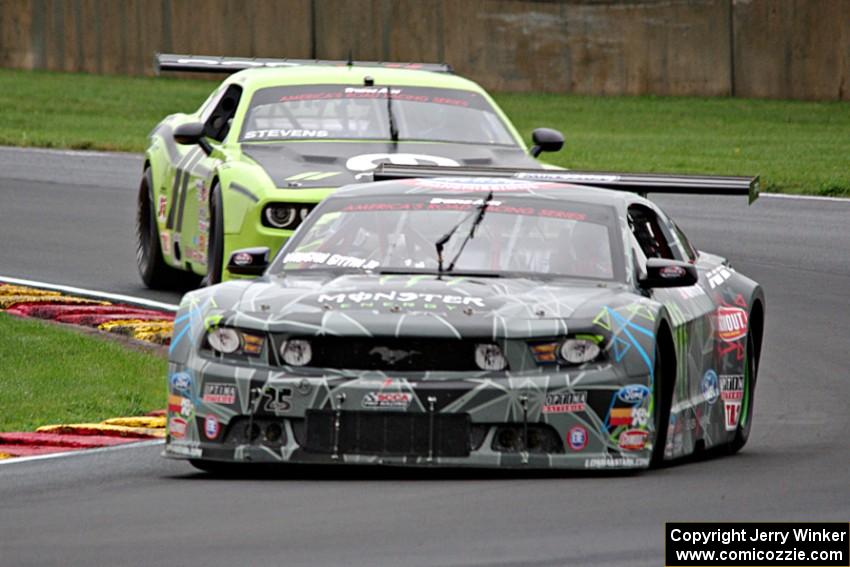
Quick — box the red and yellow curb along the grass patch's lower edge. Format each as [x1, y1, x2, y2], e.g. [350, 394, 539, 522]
[0, 412, 165, 460]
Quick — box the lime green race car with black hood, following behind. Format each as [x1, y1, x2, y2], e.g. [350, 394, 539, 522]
[137, 55, 563, 288]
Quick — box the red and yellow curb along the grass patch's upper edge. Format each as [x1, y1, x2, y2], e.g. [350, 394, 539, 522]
[0, 283, 174, 345]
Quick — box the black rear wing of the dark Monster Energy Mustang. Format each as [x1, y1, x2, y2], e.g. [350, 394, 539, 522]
[373, 163, 759, 204]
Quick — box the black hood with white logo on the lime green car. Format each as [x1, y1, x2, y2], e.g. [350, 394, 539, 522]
[242, 141, 541, 189]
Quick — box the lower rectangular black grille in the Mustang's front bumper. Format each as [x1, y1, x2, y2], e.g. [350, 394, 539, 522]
[304, 410, 470, 457]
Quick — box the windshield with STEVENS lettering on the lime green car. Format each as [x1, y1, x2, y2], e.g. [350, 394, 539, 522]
[240, 85, 516, 146]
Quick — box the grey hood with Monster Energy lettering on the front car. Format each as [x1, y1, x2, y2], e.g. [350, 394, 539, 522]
[196, 273, 641, 339]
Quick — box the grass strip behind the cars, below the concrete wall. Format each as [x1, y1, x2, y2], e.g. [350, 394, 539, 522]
[0, 70, 850, 195]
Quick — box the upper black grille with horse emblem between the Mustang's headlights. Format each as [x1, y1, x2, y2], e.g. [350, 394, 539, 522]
[278, 337, 480, 372]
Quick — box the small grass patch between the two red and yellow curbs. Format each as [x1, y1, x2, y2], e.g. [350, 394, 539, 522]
[0, 313, 166, 431]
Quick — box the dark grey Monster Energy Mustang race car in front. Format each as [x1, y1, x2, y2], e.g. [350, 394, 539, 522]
[164, 166, 765, 470]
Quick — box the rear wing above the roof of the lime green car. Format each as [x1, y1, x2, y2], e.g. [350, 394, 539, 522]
[154, 53, 453, 75]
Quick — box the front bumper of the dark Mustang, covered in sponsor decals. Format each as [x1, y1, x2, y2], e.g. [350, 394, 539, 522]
[164, 356, 655, 470]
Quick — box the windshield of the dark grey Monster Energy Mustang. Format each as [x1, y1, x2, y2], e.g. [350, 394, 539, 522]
[271, 191, 624, 281]
